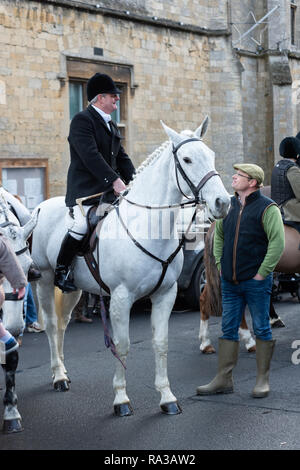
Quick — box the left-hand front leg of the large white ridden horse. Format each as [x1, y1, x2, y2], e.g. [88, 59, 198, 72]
[109, 286, 133, 416]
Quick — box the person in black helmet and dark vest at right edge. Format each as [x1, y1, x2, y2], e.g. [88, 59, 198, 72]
[271, 137, 300, 239]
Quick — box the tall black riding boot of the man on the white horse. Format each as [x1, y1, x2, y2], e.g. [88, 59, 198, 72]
[54, 233, 81, 292]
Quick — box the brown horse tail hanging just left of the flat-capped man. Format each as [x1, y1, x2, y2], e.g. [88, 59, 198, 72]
[200, 223, 222, 318]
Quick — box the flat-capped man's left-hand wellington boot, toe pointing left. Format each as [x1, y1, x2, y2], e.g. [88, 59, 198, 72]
[197, 338, 240, 395]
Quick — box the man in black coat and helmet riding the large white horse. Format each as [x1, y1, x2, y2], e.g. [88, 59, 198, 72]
[54, 73, 135, 292]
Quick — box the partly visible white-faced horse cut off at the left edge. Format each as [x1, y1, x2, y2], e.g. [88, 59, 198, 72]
[0, 196, 37, 433]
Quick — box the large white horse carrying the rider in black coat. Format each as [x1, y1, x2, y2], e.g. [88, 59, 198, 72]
[32, 118, 230, 416]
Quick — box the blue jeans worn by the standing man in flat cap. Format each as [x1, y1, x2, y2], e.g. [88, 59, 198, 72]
[221, 273, 273, 341]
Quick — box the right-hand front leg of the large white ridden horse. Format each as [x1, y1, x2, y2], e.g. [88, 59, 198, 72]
[151, 283, 181, 415]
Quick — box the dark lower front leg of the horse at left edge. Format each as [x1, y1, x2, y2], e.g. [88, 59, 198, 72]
[2, 351, 23, 434]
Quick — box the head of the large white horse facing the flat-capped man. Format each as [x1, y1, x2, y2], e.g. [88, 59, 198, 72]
[161, 116, 230, 219]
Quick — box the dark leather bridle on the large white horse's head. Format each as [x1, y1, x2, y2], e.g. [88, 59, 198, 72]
[172, 137, 220, 204]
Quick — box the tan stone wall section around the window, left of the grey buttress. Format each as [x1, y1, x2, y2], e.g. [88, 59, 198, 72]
[0, 0, 240, 196]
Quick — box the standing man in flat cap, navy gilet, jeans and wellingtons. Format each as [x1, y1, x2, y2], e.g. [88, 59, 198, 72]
[197, 163, 284, 398]
